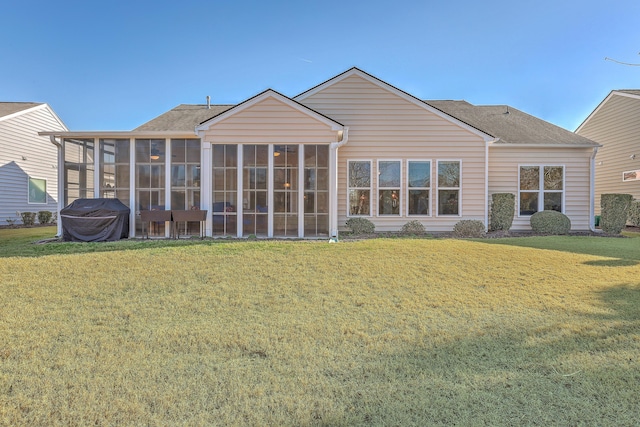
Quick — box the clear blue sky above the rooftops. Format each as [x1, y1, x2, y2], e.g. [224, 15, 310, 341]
[0, 0, 640, 131]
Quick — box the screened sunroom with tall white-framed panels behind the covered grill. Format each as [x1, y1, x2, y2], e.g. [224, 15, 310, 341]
[43, 132, 332, 237]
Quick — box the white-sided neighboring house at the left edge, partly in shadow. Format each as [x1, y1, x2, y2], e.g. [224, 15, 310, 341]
[0, 102, 67, 225]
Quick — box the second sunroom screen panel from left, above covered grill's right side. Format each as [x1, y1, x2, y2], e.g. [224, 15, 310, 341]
[100, 139, 130, 206]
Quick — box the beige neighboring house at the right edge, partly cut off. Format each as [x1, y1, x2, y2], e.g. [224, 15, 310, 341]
[576, 90, 640, 213]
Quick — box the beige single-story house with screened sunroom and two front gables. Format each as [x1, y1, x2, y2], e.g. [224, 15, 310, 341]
[41, 68, 597, 237]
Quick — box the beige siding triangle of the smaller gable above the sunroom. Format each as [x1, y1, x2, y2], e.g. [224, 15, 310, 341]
[202, 98, 337, 144]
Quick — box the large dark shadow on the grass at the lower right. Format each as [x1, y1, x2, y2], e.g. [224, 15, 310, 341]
[349, 285, 640, 425]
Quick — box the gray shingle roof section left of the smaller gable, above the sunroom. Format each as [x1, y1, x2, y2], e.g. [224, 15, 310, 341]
[134, 104, 233, 132]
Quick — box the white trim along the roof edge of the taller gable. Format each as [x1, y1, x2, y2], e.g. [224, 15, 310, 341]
[293, 67, 496, 142]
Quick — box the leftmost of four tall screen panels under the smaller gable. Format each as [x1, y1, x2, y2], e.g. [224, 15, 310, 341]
[211, 144, 238, 236]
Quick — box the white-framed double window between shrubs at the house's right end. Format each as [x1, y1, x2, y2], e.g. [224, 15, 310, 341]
[518, 166, 564, 216]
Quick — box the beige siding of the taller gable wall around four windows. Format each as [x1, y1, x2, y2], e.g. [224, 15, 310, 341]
[300, 75, 485, 232]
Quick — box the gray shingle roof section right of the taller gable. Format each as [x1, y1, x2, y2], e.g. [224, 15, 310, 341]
[425, 101, 598, 146]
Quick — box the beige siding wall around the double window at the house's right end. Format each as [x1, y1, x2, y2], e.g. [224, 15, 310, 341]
[488, 146, 593, 231]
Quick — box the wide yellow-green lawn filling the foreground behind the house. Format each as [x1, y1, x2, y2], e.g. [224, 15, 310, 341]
[0, 228, 640, 426]
